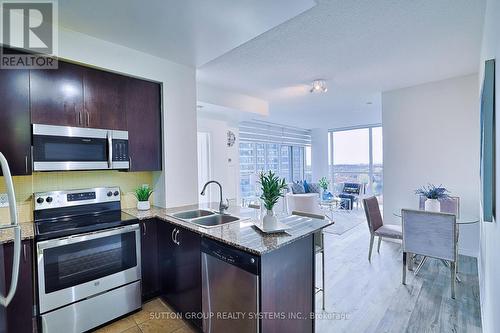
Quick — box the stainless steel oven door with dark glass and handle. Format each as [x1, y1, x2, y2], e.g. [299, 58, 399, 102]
[37, 224, 141, 314]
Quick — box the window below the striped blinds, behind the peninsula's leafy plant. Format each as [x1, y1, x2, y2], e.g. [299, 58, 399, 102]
[240, 141, 311, 198]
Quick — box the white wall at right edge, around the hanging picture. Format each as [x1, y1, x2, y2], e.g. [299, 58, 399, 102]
[479, 0, 500, 333]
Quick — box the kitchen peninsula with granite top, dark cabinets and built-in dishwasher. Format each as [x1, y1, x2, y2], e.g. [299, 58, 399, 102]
[125, 204, 333, 332]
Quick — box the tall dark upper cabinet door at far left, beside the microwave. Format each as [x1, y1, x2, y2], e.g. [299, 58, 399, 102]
[0, 69, 31, 176]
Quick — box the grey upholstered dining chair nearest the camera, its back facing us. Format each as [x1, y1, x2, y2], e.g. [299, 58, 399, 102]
[401, 209, 457, 299]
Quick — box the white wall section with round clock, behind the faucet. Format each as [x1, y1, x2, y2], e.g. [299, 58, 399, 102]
[198, 112, 240, 203]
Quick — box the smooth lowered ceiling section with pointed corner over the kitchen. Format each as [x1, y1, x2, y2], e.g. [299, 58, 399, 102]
[58, 0, 316, 67]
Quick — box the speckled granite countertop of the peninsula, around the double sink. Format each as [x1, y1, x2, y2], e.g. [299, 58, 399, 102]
[123, 203, 333, 255]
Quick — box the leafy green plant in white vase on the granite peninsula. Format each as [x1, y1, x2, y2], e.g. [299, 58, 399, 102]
[259, 170, 287, 224]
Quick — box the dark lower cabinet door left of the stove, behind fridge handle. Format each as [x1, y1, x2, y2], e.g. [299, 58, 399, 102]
[4, 240, 35, 333]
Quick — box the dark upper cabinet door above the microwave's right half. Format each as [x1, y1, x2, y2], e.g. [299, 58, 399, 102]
[83, 68, 127, 130]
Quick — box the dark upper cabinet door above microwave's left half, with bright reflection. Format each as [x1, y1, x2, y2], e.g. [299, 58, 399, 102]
[30, 61, 84, 127]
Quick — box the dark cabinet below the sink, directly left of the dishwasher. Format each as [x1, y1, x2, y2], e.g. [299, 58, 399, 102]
[158, 222, 202, 327]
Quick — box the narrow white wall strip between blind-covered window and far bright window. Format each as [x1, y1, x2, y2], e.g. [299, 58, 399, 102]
[311, 128, 330, 182]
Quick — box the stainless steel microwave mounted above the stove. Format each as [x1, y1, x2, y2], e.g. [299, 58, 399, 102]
[33, 124, 130, 171]
